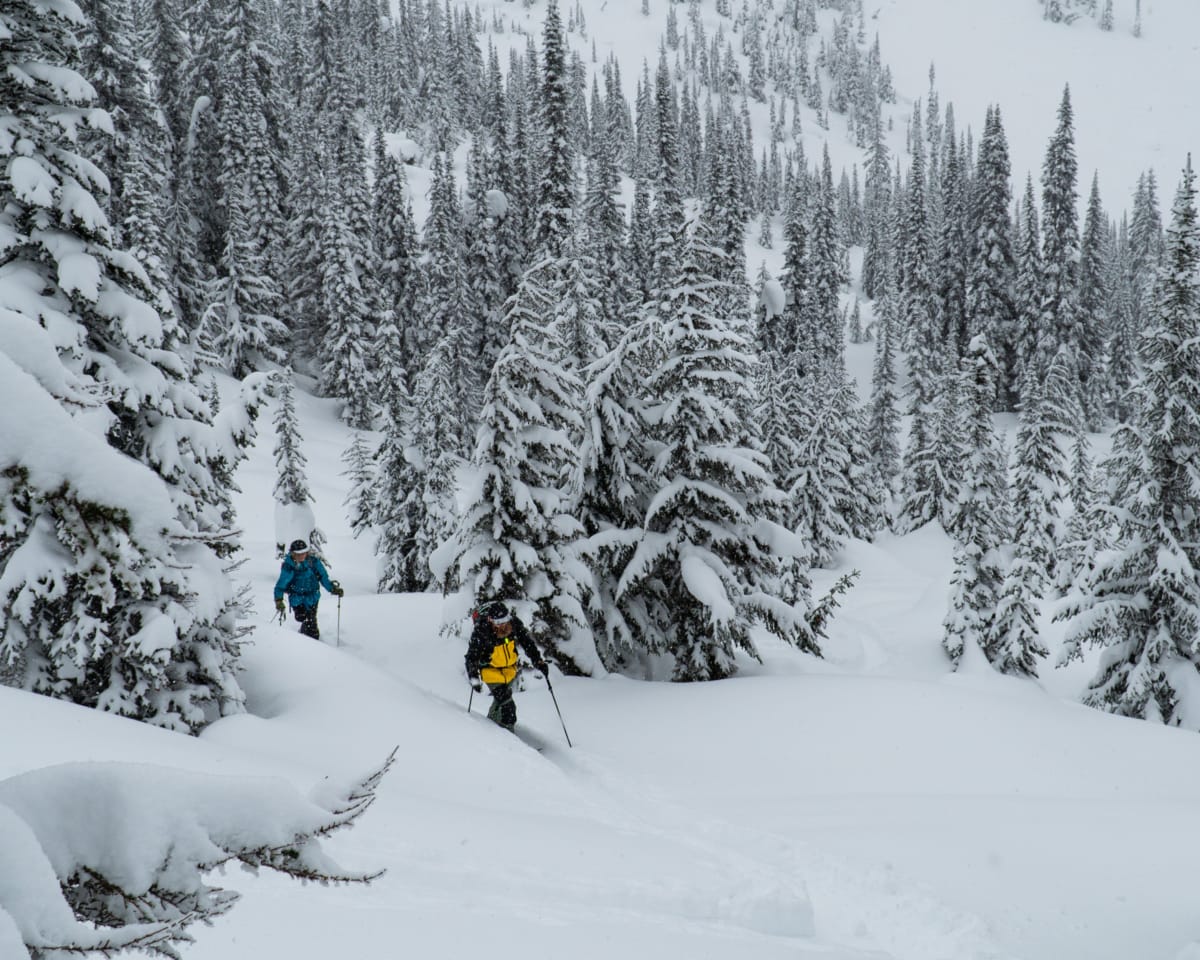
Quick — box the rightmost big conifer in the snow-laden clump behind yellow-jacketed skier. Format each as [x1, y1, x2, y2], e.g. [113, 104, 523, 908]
[617, 228, 804, 680]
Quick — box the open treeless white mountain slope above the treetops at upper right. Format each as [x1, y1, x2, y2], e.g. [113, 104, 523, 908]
[866, 0, 1200, 214]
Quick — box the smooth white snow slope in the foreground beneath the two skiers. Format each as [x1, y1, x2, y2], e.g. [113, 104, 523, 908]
[0, 379, 1200, 960]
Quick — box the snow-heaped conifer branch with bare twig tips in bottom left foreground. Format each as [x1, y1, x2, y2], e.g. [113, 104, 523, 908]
[0, 754, 395, 960]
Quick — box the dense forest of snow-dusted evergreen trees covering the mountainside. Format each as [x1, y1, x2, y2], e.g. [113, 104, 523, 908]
[0, 0, 1200, 730]
